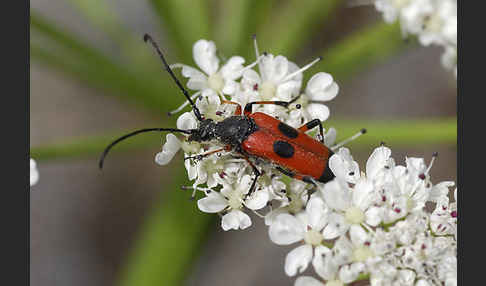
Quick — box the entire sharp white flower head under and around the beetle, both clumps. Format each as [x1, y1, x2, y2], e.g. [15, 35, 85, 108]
[155, 40, 457, 286]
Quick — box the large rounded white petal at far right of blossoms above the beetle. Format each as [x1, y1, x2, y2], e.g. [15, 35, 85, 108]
[305, 72, 339, 101]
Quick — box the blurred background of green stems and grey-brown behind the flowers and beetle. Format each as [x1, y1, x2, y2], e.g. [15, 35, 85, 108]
[30, 0, 457, 286]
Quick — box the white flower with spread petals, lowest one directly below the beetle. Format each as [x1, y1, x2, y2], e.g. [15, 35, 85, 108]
[197, 175, 269, 230]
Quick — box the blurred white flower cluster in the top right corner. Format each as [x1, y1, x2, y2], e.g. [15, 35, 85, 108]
[375, 0, 457, 78]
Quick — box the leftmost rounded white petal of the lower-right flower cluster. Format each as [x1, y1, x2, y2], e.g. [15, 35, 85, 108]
[268, 213, 305, 245]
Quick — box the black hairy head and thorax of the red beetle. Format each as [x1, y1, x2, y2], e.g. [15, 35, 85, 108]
[188, 116, 258, 148]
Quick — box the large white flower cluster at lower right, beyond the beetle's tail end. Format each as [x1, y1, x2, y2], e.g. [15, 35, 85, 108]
[276, 146, 457, 286]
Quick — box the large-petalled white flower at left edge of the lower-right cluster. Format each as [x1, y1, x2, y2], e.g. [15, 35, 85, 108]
[268, 197, 329, 276]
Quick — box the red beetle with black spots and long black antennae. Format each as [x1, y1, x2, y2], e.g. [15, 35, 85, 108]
[99, 34, 366, 197]
